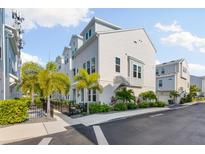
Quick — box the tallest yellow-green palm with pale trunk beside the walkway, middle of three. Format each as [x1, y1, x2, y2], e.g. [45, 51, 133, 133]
[38, 62, 70, 118]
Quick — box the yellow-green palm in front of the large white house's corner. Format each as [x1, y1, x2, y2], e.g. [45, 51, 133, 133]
[74, 69, 102, 114]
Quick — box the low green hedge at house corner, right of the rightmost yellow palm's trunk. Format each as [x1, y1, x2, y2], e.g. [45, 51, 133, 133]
[89, 103, 110, 113]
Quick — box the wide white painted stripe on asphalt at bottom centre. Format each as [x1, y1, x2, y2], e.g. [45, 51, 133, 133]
[93, 126, 108, 145]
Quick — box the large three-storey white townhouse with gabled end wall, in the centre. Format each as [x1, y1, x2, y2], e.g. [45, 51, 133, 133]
[58, 17, 156, 103]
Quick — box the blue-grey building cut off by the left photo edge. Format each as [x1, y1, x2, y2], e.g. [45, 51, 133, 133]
[0, 9, 21, 100]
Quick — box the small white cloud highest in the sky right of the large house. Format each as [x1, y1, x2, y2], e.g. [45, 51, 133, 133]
[155, 21, 183, 32]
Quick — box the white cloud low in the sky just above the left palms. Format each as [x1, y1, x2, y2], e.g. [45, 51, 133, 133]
[21, 52, 45, 66]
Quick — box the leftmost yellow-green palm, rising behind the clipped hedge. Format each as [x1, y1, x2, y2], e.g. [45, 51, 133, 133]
[19, 62, 42, 104]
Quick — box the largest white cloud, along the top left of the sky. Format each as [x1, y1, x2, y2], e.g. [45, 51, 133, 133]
[6, 8, 93, 30]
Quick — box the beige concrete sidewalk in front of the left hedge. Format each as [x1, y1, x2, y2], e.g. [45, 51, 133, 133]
[0, 116, 69, 144]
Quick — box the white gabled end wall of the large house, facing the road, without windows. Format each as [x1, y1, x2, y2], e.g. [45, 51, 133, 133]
[99, 29, 155, 102]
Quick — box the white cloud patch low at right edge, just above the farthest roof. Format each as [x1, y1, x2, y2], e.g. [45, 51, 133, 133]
[189, 63, 205, 76]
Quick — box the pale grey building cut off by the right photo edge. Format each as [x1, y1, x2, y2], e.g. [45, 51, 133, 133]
[190, 75, 205, 96]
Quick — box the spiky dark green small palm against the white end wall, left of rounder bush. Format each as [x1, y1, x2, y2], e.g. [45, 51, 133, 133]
[116, 88, 135, 103]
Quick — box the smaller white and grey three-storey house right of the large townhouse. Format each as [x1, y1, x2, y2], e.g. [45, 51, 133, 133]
[156, 59, 190, 103]
